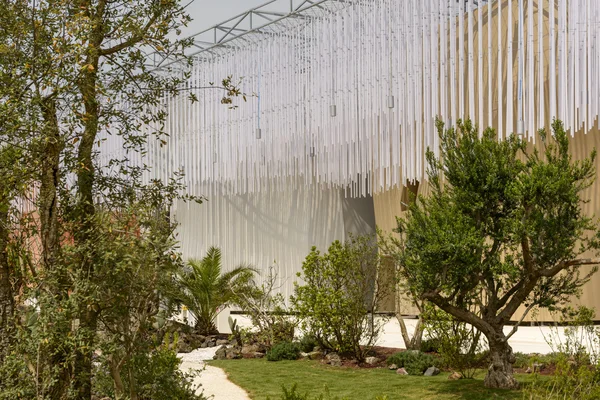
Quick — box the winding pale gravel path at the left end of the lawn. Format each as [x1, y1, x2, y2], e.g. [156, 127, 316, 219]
[178, 347, 250, 400]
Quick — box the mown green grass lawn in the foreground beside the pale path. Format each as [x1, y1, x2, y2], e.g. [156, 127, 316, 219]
[209, 359, 531, 400]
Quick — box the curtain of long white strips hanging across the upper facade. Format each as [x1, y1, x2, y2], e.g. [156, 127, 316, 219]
[103, 0, 600, 196]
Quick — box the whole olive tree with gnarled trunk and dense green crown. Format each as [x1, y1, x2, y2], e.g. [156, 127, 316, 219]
[390, 121, 599, 388]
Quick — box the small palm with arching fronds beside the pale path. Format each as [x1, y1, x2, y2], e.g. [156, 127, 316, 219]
[178, 247, 256, 335]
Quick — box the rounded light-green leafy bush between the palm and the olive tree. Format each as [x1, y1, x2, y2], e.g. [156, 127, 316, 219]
[292, 236, 382, 361]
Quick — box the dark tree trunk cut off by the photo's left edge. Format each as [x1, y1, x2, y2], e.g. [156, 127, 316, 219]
[0, 210, 14, 364]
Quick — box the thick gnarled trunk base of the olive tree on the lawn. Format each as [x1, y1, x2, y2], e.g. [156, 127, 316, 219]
[483, 328, 519, 389]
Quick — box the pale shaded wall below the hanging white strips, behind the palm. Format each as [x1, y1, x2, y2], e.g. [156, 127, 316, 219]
[174, 181, 375, 297]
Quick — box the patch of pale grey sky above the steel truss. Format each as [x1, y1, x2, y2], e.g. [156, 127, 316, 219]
[182, 0, 267, 37]
